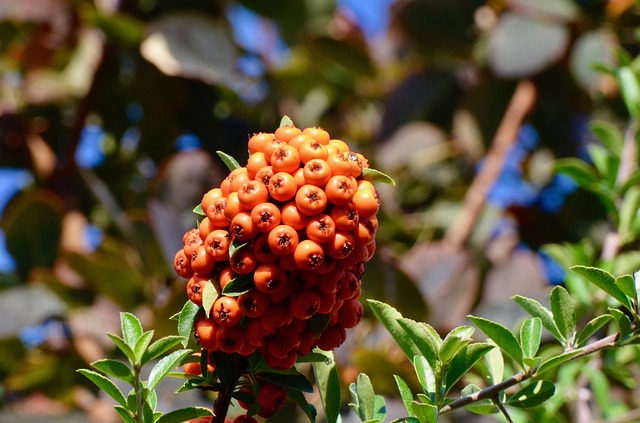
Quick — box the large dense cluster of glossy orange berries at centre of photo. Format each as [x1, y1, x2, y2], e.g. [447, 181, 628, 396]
[174, 122, 380, 369]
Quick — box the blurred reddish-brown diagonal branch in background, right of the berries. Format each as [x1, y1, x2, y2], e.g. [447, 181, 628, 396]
[444, 80, 536, 251]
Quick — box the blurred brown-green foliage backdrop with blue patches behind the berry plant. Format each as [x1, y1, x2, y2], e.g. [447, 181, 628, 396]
[0, 0, 640, 421]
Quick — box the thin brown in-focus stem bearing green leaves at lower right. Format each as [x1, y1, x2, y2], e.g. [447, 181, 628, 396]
[439, 333, 620, 414]
